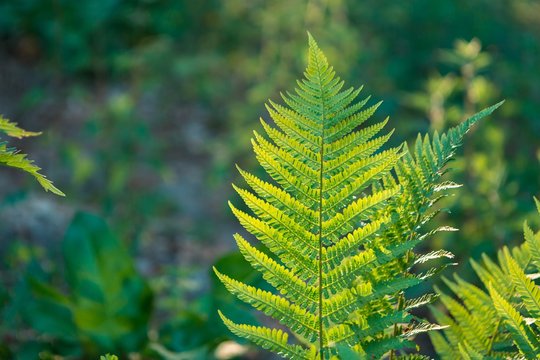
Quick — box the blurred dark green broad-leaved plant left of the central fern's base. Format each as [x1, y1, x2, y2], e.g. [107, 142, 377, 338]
[21, 213, 152, 356]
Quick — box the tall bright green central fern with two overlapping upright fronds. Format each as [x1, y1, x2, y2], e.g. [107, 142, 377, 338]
[215, 36, 495, 359]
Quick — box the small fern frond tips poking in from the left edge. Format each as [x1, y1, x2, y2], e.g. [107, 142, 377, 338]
[0, 115, 64, 196]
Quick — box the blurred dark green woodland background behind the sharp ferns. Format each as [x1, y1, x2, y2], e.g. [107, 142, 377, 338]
[0, 0, 540, 359]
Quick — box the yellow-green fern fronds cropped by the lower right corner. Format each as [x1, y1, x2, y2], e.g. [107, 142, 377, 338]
[430, 199, 540, 360]
